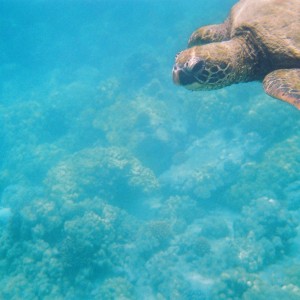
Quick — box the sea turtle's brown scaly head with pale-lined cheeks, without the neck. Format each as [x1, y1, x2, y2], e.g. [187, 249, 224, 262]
[173, 43, 237, 90]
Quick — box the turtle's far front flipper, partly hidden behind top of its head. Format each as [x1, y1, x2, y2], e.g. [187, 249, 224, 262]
[188, 20, 230, 47]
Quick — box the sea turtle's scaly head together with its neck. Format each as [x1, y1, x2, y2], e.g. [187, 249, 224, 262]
[173, 37, 258, 90]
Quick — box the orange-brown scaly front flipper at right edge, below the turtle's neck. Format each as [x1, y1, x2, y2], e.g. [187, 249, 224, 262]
[263, 69, 300, 109]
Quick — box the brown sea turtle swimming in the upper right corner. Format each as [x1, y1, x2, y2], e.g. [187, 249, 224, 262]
[173, 0, 300, 109]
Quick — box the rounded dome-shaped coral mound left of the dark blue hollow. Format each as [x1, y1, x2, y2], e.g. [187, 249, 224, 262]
[45, 147, 159, 209]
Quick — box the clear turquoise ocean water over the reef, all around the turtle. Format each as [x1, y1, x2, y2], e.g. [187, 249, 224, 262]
[0, 0, 300, 300]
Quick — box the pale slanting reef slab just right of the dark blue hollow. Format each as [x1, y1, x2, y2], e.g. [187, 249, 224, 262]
[160, 128, 261, 202]
